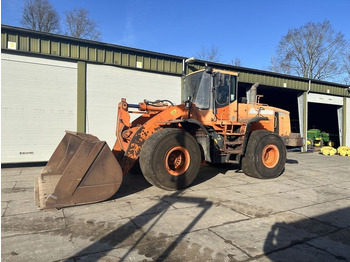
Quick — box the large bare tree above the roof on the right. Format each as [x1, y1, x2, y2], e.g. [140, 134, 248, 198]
[273, 20, 346, 80]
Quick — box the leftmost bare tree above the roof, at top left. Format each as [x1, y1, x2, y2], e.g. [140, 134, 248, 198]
[21, 0, 60, 33]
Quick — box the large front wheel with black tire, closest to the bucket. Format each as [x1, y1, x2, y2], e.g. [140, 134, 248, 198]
[140, 128, 201, 190]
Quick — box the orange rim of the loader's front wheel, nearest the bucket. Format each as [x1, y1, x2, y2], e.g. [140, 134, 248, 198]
[164, 146, 190, 176]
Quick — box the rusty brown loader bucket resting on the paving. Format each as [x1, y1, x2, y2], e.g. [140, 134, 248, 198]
[35, 131, 123, 209]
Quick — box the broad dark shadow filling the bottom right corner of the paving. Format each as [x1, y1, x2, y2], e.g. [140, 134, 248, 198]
[264, 207, 350, 261]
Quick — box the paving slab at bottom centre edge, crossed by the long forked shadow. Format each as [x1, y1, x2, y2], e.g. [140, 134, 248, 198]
[75, 230, 249, 262]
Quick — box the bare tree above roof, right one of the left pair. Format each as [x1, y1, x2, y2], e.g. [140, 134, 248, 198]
[65, 8, 101, 40]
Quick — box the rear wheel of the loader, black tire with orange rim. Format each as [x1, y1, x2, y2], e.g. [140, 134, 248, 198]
[242, 130, 287, 179]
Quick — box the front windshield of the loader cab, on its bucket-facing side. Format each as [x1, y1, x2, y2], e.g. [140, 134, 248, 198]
[182, 71, 211, 109]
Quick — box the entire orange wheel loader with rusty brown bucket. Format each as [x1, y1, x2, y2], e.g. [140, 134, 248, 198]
[35, 67, 302, 209]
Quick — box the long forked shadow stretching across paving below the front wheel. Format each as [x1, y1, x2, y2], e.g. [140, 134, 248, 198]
[65, 191, 212, 261]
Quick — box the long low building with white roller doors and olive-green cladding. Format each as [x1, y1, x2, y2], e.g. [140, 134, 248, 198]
[1, 25, 350, 163]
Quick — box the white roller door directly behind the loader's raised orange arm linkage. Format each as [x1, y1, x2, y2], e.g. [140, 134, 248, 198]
[86, 64, 181, 148]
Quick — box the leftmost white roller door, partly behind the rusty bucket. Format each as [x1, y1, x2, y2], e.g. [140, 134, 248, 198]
[1, 54, 77, 163]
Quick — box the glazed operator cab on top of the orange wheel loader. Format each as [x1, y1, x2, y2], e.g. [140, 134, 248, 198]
[182, 68, 237, 110]
